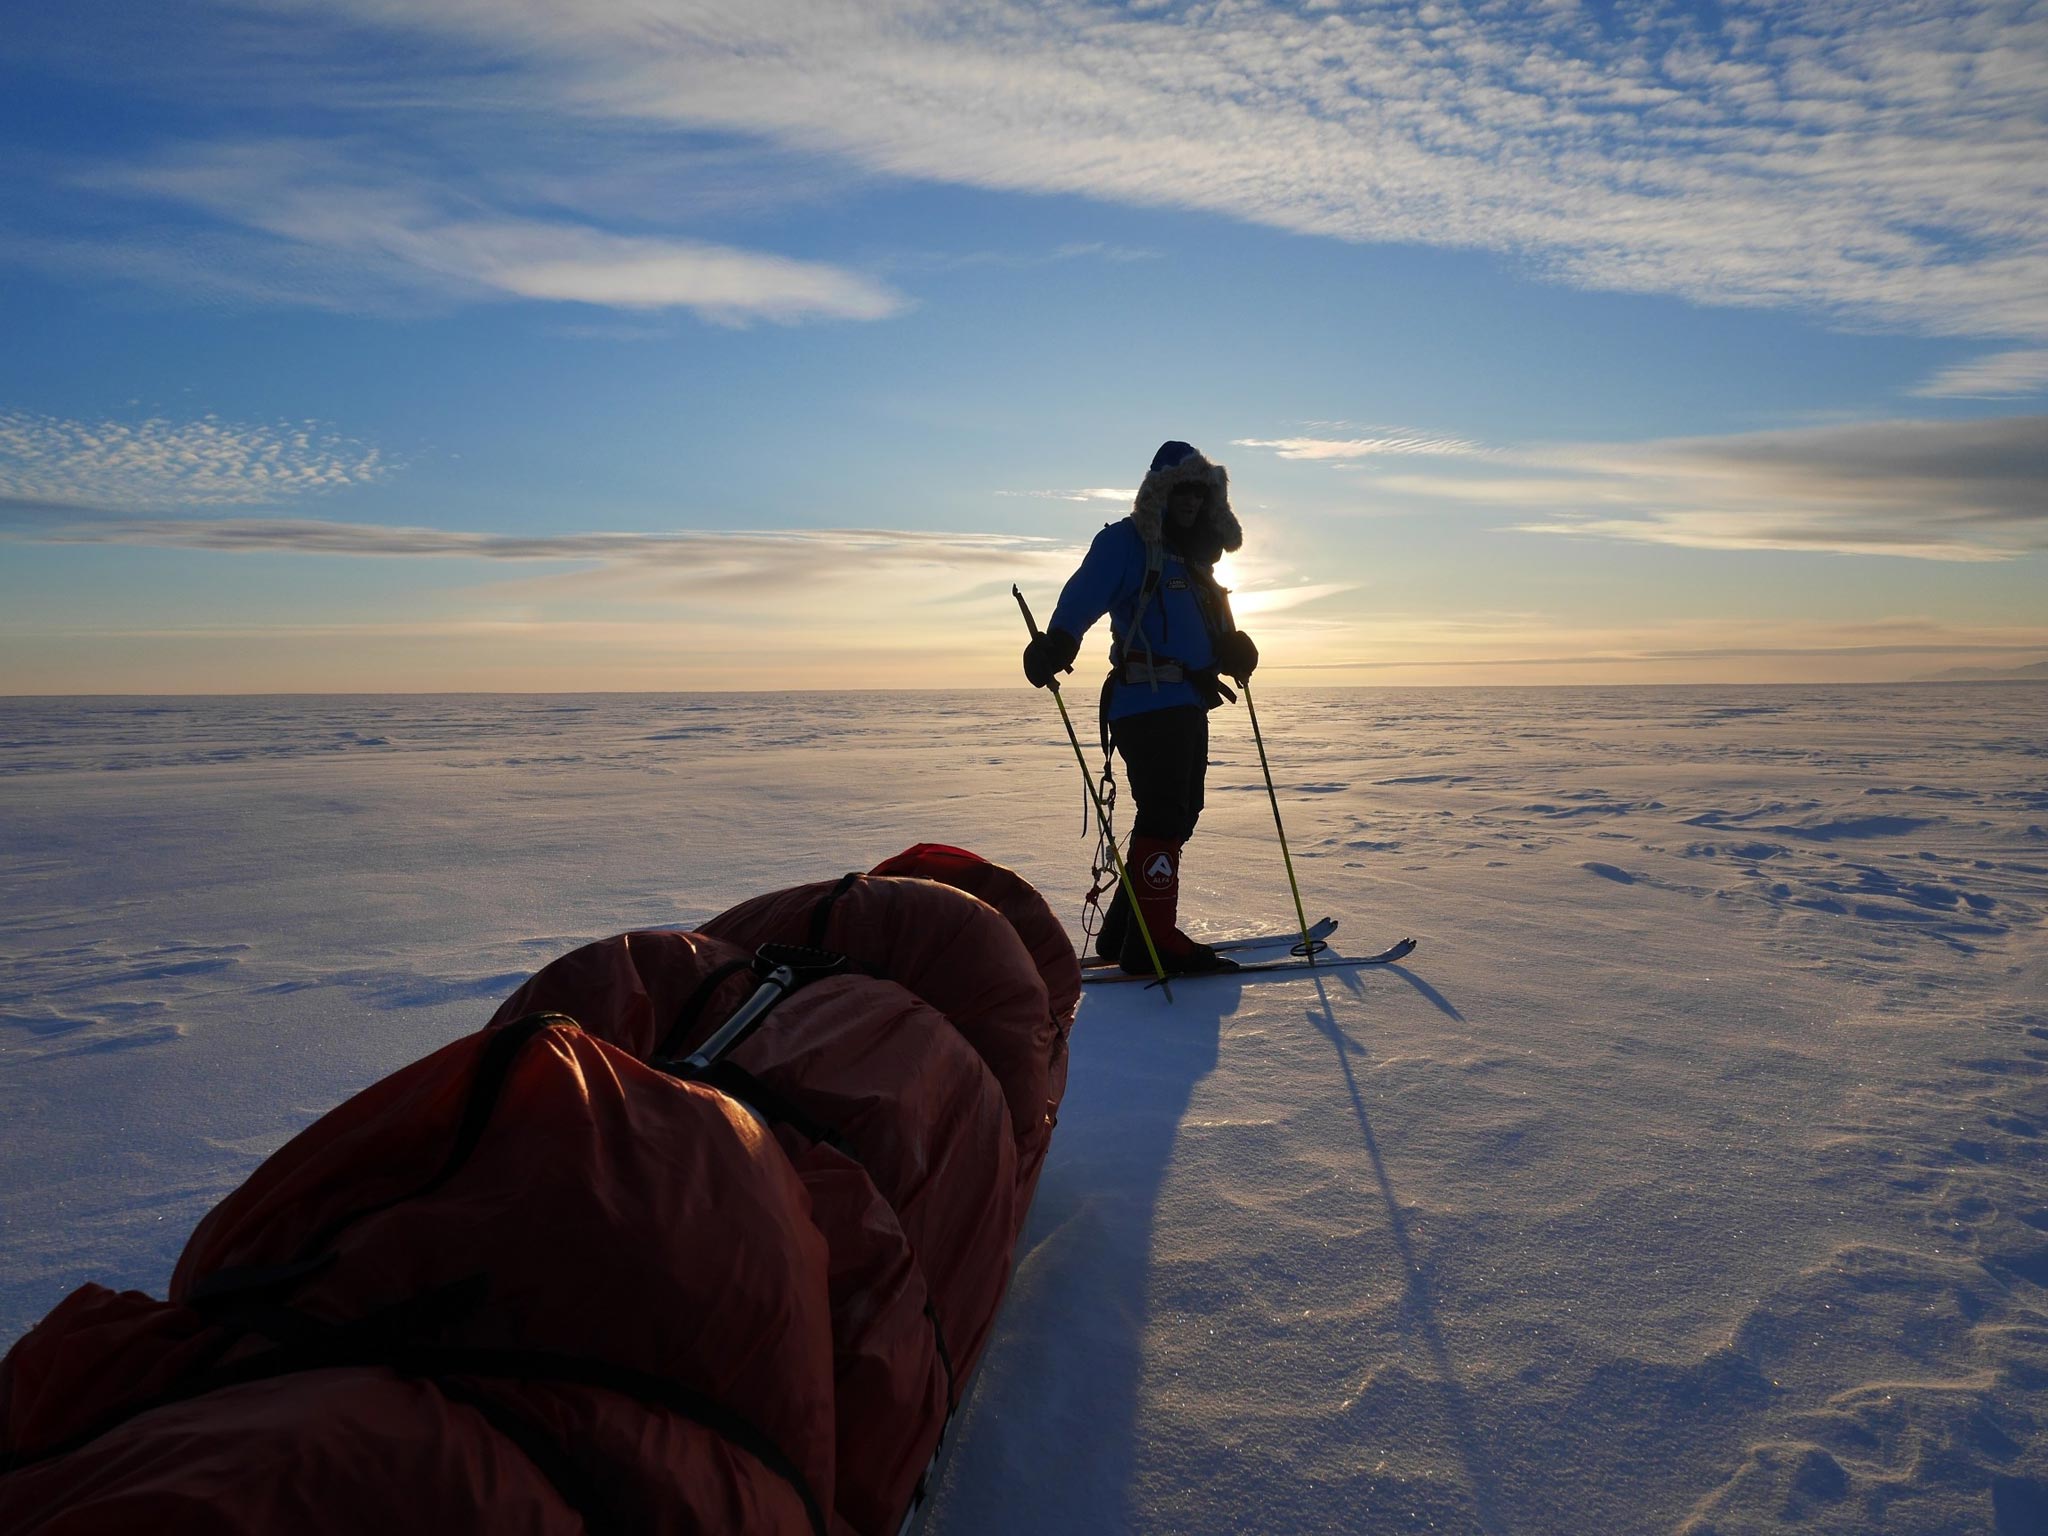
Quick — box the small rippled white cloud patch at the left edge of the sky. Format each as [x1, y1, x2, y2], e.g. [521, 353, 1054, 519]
[0, 412, 391, 510]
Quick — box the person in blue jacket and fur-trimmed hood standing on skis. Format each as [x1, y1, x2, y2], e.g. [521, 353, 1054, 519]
[1024, 442, 1260, 975]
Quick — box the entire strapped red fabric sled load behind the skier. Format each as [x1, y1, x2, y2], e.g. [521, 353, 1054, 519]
[0, 846, 1077, 1536]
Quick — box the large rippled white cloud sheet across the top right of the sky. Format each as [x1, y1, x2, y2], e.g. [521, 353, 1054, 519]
[211, 0, 2048, 340]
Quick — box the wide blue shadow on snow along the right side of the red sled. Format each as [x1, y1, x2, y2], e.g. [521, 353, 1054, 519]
[922, 983, 1239, 1536]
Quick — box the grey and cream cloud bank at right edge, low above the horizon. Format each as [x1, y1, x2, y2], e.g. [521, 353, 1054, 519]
[1372, 416, 2048, 561]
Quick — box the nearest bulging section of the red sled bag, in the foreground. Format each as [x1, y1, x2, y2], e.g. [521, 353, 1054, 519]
[0, 1016, 834, 1536]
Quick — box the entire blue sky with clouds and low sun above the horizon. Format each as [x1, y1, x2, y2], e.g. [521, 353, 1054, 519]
[0, 0, 2048, 694]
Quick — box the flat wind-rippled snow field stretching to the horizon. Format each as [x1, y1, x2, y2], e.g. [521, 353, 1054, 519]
[0, 684, 2048, 1536]
